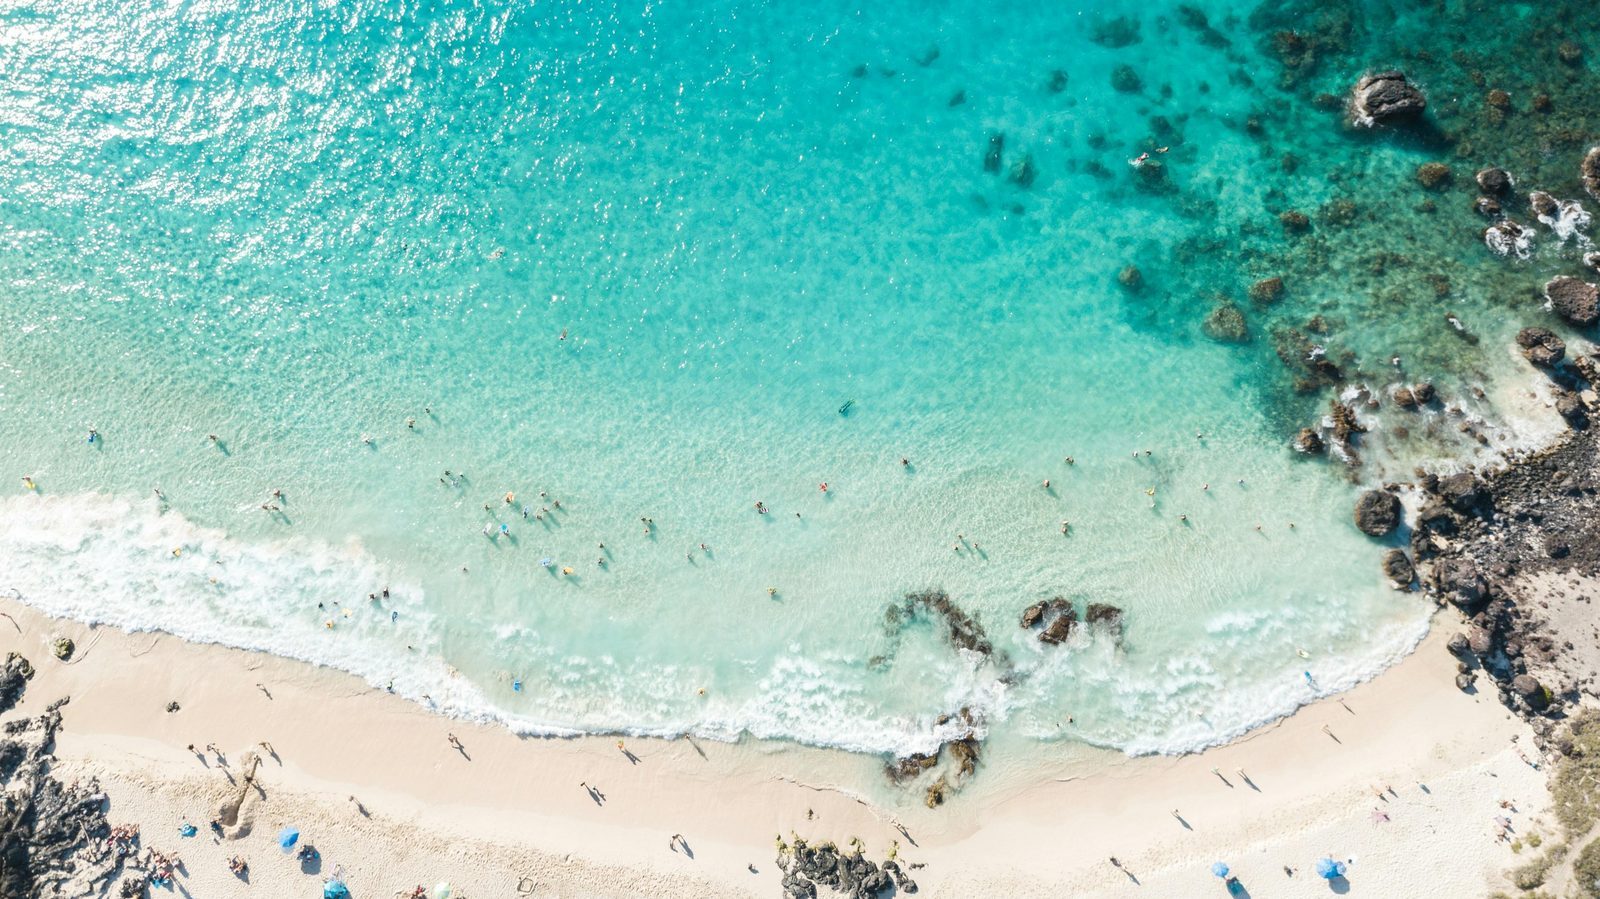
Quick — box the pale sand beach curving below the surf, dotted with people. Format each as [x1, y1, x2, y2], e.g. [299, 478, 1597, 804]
[0, 601, 1549, 899]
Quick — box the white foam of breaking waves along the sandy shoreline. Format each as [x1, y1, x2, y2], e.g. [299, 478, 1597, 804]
[0, 494, 1426, 755]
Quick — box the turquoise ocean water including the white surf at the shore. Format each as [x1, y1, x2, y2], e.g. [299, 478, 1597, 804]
[0, 0, 1576, 771]
